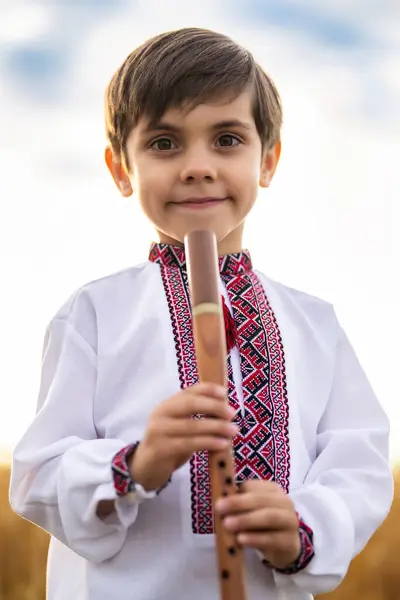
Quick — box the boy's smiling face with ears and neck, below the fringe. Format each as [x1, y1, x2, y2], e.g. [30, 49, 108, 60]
[107, 92, 280, 254]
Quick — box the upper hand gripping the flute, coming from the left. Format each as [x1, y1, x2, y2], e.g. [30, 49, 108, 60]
[129, 383, 237, 490]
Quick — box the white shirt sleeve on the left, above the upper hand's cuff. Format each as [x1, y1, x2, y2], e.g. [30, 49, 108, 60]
[10, 290, 153, 562]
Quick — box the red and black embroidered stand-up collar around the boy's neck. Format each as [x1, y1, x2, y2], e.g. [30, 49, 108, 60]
[149, 242, 253, 275]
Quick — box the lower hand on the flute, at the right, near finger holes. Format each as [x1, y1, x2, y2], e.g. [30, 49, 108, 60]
[217, 479, 301, 569]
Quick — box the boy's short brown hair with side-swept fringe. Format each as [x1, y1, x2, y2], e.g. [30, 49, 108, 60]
[106, 28, 282, 168]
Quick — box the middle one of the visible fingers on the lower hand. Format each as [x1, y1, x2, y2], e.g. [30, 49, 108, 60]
[223, 508, 298, 533]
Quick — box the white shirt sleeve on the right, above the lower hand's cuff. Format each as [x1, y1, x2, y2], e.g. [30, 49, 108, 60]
[273, 330, 393, 594]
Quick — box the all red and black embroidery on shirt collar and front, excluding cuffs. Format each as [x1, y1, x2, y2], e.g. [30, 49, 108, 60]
[150, 244, 289, 534]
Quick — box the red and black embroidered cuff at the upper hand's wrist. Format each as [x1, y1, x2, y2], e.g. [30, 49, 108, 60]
[111, 442, 171, 501]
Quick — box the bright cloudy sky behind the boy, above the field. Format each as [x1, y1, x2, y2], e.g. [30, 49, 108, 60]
[0, 0, 400, 461]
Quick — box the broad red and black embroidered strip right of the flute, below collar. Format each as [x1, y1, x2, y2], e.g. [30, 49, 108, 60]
[222, 271, 290, 492]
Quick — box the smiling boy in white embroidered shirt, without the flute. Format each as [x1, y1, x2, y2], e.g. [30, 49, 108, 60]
[11, 29, 393, 600]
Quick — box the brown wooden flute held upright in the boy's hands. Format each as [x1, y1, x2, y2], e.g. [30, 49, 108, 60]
[185, 231, 246, 600]
